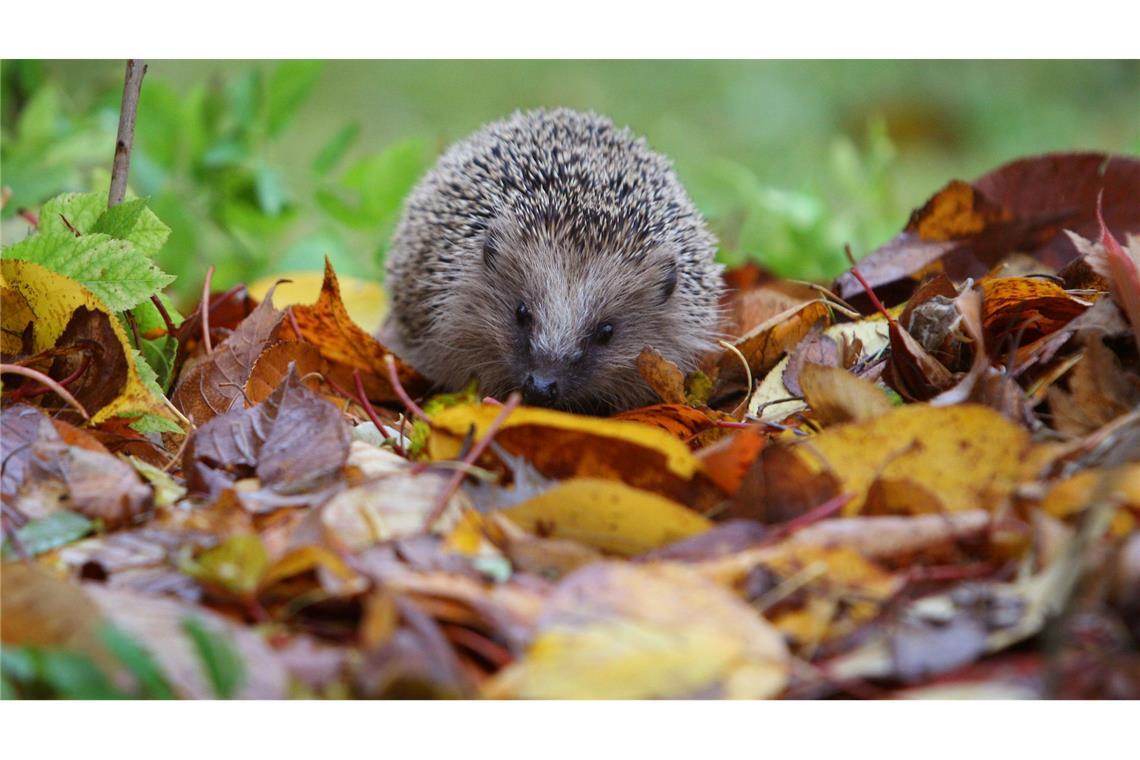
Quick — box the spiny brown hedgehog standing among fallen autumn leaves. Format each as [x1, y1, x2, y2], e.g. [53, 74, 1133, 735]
[382, 108, 723, 414]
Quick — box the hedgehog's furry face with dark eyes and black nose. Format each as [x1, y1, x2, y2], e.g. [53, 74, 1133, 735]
[475, 224, 677, 414]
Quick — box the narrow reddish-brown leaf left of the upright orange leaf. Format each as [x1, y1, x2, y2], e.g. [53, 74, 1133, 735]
[170, 288, 285, 425]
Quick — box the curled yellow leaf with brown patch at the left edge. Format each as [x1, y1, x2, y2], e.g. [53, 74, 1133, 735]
[0, 259, 174, 424]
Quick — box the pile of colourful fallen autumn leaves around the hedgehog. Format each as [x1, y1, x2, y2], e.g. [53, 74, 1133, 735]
[2, 154, 1140, 698]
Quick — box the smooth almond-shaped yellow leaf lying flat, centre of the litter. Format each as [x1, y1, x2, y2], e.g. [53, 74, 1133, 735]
[503, 477, 713, 556]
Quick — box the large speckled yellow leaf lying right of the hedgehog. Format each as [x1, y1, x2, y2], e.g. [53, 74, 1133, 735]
[793, 403, 1036, 515]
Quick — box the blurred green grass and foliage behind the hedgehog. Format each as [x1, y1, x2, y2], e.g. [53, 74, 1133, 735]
[0, 60, 1140, 299]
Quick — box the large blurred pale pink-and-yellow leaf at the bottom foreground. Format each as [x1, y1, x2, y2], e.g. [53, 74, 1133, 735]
[485, 562, 789, 700]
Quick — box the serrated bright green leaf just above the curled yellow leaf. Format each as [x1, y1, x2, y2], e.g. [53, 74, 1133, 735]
[3, 232, 174, 311]
